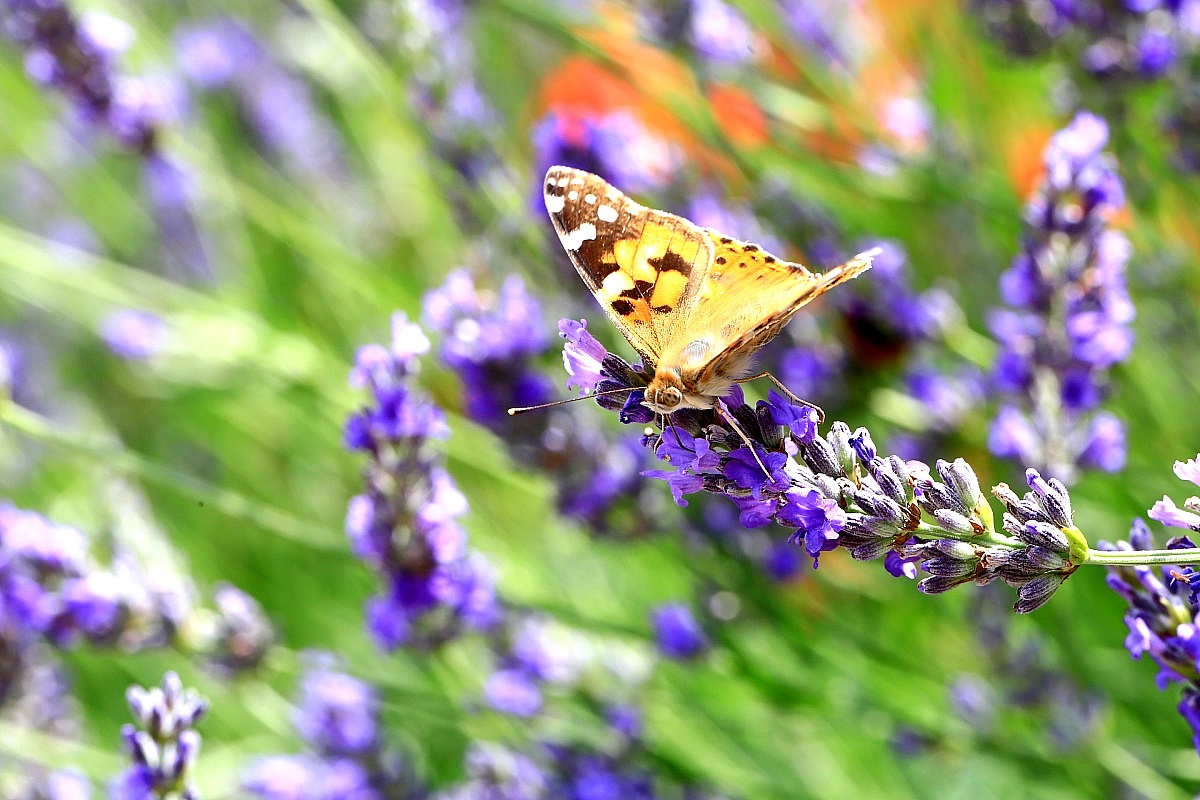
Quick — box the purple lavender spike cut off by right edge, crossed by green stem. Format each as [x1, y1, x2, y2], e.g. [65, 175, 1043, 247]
[1100, 515, 1200, 752]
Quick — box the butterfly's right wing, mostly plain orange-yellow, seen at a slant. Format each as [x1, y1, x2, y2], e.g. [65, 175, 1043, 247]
[662, 239, 875, 396]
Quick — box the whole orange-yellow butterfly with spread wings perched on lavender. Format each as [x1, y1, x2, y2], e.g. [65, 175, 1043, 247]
[544, 167, 875, 415]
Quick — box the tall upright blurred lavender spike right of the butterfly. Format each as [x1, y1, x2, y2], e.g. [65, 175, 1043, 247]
[990, 113, 1134, 477]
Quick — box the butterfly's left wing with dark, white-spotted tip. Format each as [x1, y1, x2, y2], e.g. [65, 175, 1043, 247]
[544, 167, 713, 365]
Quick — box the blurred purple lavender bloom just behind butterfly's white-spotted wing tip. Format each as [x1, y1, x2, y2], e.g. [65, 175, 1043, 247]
[533, 110, 682, 196]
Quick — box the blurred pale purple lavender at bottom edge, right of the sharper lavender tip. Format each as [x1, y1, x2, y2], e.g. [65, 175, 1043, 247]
[241, 654, 426, 800]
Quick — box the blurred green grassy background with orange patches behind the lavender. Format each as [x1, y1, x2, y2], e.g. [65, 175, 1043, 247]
[0, 0, 1200, 798]
